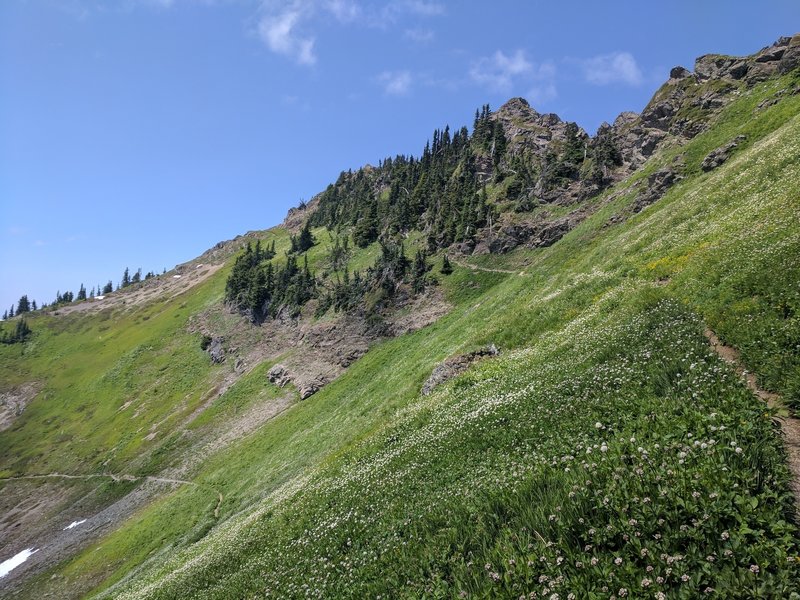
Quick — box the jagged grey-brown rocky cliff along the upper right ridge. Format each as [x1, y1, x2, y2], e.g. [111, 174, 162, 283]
[456, 34, 800, 254]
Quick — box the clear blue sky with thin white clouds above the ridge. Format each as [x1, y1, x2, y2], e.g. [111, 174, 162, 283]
[0, 0, 800, 313]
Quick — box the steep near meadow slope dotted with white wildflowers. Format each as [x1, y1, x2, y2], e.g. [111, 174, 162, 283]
[0, 71, 800, 597]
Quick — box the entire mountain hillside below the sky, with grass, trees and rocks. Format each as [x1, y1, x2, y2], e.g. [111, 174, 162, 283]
[0, 36, 800, 598]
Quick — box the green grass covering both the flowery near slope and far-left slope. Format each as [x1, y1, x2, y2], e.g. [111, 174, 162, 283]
[0, 71, 800, 598]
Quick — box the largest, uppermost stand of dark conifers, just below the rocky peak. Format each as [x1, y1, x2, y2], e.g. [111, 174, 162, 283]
[310, 105, 622, 252]
